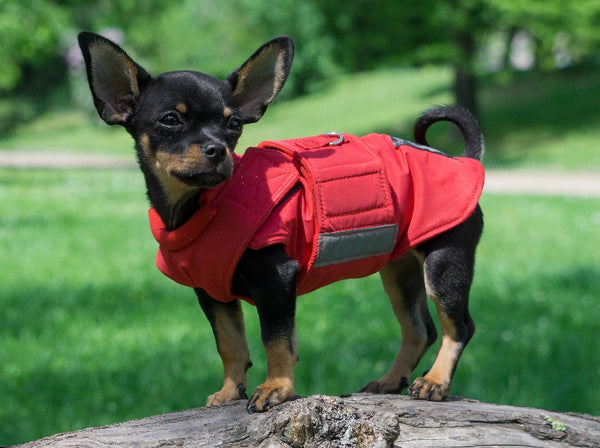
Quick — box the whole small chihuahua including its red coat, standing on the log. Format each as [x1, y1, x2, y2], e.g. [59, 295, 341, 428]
[79, 32, 483, 412]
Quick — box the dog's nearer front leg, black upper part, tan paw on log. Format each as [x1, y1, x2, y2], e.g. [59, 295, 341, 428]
[238, 246, 299, 412]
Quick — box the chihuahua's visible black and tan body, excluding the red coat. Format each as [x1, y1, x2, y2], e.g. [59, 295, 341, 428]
[79, 32, 483, 411]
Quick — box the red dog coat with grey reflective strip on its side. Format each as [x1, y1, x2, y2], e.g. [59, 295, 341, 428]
[149, 134, 484, 303]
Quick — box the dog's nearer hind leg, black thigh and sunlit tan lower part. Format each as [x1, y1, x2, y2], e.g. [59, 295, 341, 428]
[409, 209, 483, 401]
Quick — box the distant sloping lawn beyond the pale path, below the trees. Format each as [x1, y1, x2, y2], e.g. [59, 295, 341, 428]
[0, 67, 600, 170]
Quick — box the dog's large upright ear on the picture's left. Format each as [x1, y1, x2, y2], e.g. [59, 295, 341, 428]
[78, 32, 151, 125]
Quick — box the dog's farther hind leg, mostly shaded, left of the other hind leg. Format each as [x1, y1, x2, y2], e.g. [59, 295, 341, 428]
[361, 253, 437, 394]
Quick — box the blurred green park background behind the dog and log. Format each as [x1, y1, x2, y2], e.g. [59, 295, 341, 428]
[0, 0, 600, 445]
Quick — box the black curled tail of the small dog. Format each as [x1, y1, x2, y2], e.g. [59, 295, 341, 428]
[414, 106, 485, 160]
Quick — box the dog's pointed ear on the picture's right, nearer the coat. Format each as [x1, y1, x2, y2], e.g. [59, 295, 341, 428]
[227, 36, 294, 123]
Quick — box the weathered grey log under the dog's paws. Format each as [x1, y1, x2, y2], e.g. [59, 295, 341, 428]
[10, 394, 600, 448]
